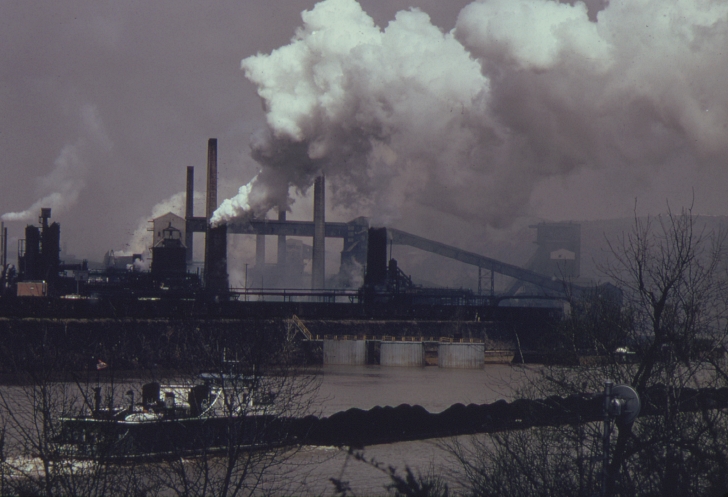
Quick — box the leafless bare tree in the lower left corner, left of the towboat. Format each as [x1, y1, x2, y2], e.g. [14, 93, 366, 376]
[0, 324, 146, 496]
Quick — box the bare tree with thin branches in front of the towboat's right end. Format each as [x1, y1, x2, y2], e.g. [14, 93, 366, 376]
[148, 321, 319, 496]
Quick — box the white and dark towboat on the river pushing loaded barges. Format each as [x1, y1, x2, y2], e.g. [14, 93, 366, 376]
[57, 374, 279, 459]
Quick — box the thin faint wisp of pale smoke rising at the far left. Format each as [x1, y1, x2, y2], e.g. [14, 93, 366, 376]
[0, 104, 113, 222]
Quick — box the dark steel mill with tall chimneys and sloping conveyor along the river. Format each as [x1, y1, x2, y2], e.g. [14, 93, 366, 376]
[0, 139, 610, 367]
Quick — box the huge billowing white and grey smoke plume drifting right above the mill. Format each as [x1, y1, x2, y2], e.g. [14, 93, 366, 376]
[216, 0, 728, 227]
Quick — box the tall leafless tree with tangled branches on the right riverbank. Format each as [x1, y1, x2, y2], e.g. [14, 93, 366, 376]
[449, 209, 728, 496]
